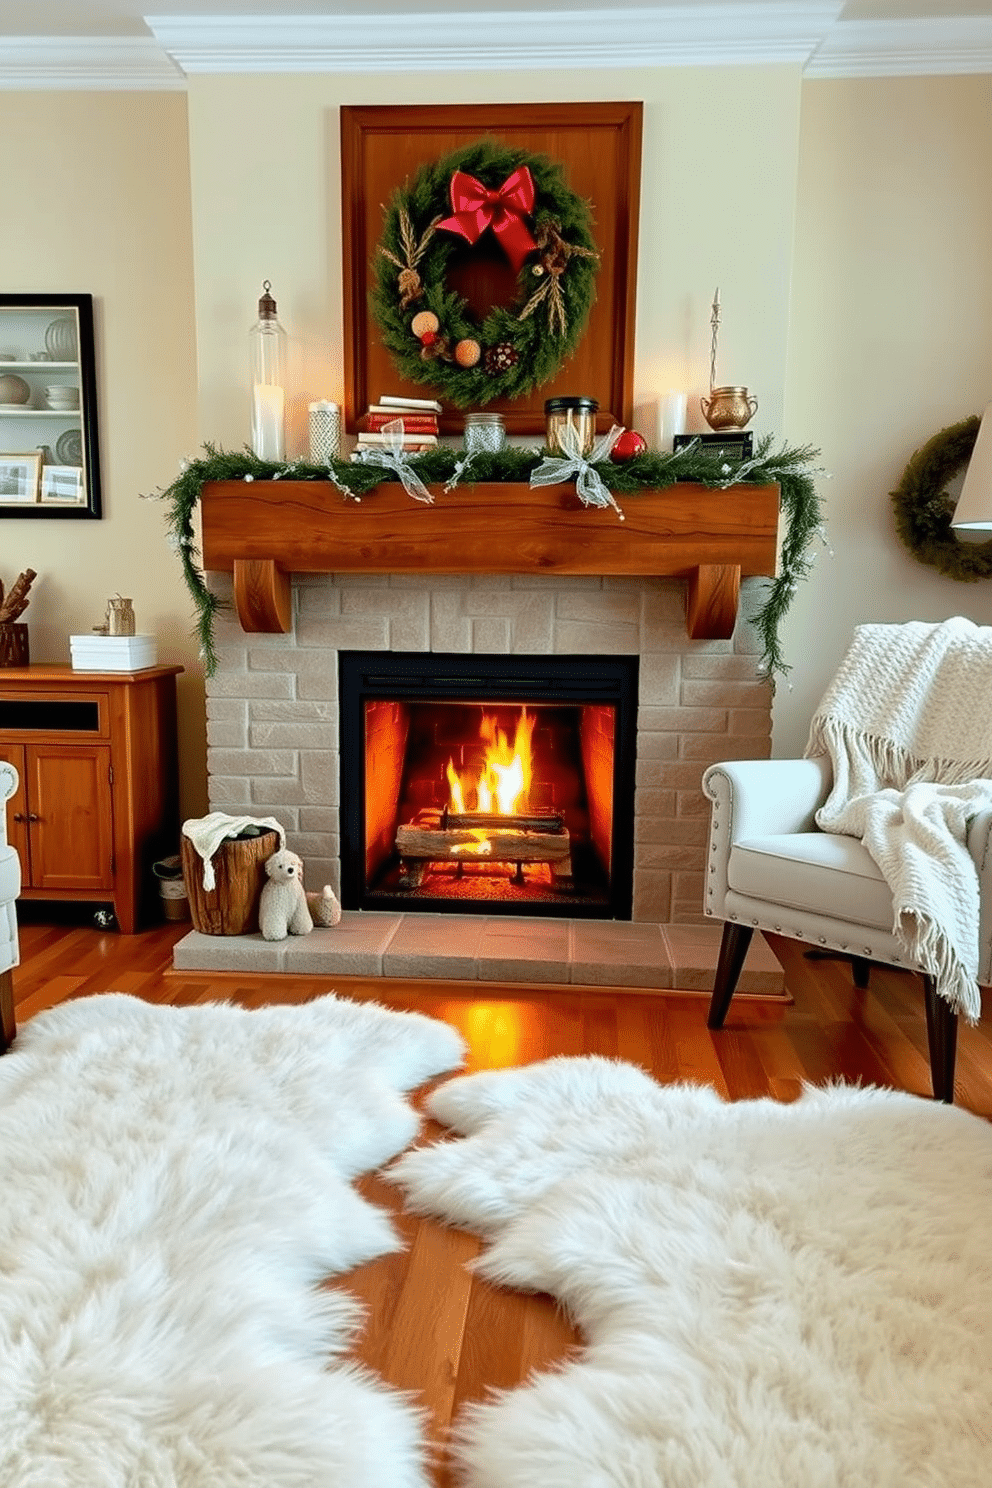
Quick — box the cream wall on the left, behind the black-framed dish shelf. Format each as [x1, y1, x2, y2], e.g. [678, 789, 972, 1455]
[0, 92, 207, 815]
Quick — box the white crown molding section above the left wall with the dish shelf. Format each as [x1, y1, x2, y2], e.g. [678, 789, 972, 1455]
[0, 36, 186, 92]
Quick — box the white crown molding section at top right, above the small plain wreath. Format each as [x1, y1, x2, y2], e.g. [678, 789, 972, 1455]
[806, 15, 992, 77]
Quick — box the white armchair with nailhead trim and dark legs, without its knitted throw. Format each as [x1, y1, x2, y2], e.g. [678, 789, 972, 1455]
[703, 757, 992, 1103]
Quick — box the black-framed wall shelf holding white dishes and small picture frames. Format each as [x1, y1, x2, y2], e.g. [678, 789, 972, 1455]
[0, 295, 101, 521]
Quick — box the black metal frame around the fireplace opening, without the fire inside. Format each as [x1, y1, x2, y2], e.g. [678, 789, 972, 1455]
[338, 652, 640, 920]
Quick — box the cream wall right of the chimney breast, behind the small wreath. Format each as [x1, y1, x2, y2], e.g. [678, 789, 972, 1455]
[775, 76, 992, 757]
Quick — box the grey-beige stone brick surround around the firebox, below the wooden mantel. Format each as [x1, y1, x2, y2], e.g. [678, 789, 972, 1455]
[175, 573, 776, 991]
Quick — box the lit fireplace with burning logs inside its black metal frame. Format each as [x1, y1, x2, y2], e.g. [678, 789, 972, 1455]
[338, 652, 638, 920]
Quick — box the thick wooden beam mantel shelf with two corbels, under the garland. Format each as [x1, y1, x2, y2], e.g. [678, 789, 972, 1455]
[201, 481, 779, 640]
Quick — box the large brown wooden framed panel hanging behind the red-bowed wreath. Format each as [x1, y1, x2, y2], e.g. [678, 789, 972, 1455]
[341, 103, 642, 434]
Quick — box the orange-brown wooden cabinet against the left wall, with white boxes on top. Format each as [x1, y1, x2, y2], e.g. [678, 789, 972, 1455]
[0, 667, 183, 934]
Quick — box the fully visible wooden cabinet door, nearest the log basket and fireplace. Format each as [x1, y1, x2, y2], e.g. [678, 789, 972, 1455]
[25, 744, 113, 888]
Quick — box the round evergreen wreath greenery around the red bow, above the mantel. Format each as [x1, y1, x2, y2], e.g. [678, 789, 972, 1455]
[369, 140, 598, 408]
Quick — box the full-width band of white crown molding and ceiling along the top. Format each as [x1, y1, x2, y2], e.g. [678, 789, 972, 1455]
[0, 0, 992, 89]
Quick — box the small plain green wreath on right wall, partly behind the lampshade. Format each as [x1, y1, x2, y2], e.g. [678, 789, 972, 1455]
[892, 417, 992, 583]
